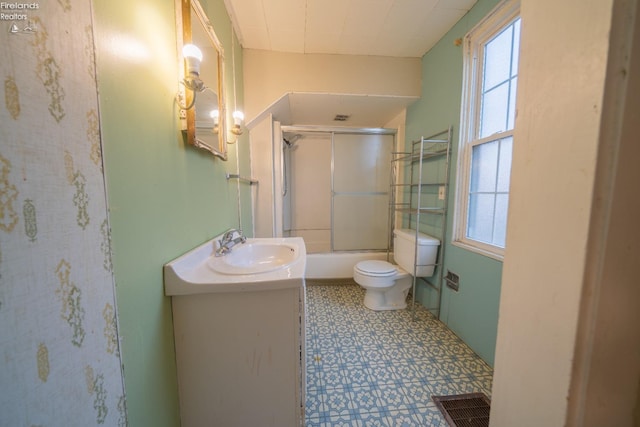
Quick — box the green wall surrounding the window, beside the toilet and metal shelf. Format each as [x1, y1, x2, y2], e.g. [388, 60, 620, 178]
[406, 0, 502, 365]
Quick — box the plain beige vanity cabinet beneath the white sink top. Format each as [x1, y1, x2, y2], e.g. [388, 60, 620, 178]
[172, 278, 305, 427]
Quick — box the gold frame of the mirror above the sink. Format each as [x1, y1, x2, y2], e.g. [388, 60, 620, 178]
[176, 0, 227, 160]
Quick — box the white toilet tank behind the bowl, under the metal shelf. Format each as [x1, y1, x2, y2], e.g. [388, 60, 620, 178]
[393, 228, 440, 277]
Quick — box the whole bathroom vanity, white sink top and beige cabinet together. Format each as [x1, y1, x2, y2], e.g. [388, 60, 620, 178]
[164, 238, 306, 427]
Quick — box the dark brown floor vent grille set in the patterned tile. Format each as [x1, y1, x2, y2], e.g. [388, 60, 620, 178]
[432, 393, 491, 427]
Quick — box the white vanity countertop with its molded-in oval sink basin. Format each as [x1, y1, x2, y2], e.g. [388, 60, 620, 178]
[164, 237, 307, 295]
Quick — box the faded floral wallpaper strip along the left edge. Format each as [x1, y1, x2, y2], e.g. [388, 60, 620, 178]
[0, 0, 127, 427]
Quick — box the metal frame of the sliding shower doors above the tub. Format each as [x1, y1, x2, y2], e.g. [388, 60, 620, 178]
[280, 125, 398, 254]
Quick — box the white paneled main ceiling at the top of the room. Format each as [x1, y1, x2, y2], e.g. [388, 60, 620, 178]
[224, 0, 477, 58]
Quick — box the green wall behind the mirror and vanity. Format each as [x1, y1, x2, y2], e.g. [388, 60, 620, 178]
[94, 0, 252, 427]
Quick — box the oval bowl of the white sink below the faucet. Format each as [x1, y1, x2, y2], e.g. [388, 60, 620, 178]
[207, 241, 298, 274]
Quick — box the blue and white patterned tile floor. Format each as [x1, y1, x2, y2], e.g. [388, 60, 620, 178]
[305, 281, 493, 427]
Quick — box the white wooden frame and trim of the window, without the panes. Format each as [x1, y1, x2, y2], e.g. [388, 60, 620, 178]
[452, 0, 522, 261]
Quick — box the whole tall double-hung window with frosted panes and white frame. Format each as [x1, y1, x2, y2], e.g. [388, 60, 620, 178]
[454, 1, 520, 259]
